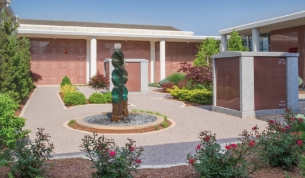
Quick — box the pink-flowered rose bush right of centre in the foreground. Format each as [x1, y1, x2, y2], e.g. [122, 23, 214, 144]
[187, 131, 249, 178]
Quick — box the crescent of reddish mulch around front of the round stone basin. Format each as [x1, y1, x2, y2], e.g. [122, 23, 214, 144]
[68, 120, 172, 134]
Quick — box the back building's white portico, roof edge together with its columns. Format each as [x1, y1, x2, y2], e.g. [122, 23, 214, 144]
[18, 19, 219, 82]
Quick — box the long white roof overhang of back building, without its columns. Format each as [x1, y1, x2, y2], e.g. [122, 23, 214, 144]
[18, 24, 220, 42]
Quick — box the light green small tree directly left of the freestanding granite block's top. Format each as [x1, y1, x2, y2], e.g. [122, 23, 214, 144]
[194, 38, 220, 66]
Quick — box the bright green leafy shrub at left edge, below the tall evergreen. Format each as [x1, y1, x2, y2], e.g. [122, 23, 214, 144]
[0, 94, 29, 148]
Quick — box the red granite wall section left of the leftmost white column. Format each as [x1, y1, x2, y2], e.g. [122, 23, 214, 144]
[30, 38, 86, 85]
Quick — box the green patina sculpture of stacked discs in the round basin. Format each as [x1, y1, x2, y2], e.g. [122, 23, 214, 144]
[111, 43, 128, 122]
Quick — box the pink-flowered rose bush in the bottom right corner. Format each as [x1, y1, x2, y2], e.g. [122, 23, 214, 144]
[241, 108, 304, 170]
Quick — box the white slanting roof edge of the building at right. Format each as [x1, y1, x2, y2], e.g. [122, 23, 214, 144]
[219, 11, 305, 35]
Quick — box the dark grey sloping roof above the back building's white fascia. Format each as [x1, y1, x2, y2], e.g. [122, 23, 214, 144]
[19, 19, 180, 31]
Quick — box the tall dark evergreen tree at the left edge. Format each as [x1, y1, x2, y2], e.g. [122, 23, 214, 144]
[0, 13, 34, 103]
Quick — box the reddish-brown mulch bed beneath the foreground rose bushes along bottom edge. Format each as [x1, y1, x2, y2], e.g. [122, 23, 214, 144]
[0, 158, 302, 178]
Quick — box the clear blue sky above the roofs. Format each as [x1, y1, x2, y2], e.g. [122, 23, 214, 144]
[11, 0, 305, 36]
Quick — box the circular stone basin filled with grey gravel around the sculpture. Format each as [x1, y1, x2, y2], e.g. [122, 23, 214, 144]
[75, 113, 164, 130]
